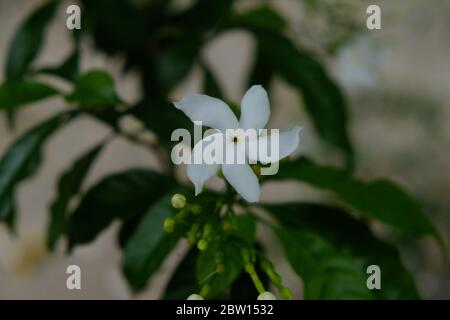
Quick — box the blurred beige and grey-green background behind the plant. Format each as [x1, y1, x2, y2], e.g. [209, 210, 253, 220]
[0, 0, 450, 299]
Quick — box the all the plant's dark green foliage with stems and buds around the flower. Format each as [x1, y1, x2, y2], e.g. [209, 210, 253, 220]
[0, 0, 439, 299]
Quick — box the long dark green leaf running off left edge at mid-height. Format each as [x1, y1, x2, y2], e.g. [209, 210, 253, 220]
[0, 113, 72, 228]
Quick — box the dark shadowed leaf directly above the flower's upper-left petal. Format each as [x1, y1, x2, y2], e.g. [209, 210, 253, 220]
[157, 39, 200, 90]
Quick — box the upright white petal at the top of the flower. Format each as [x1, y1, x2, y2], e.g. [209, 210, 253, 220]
[239, 85, 270, 129]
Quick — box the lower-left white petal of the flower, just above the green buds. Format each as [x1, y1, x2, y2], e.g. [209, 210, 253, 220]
[187, 133, 221, 195]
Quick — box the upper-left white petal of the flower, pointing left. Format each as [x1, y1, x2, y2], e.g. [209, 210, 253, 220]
[173, 94, 239, 130]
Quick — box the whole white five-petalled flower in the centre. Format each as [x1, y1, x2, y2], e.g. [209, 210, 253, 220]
[174, 85, 300, 202]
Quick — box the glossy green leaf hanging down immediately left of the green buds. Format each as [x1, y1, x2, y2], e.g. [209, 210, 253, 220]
[122, 194, 181, 291]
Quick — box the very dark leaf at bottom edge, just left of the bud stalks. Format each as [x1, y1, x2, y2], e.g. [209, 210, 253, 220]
[163, 249, 200, 300]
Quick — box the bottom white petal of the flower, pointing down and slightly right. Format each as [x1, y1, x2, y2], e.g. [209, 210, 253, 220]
[222, 164, 259, 202]
